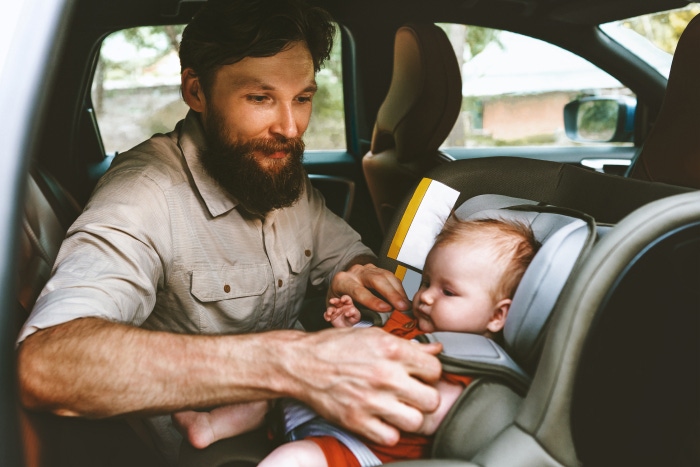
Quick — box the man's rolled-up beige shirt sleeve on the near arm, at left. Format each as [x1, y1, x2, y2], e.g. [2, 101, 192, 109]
[18, 171, 170, 342]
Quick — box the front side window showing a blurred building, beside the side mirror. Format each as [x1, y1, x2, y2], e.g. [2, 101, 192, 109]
[440, 24, 634, 152]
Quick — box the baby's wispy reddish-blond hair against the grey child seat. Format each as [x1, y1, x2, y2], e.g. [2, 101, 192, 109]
[435, 214, 540, 300]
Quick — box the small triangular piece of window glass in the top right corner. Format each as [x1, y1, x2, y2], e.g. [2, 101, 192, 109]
[600, 3, 700, 78]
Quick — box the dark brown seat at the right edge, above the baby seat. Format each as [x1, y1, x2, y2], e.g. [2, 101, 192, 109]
[629, 16, 700, 188]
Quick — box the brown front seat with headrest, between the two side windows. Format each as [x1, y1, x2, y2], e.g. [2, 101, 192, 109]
[362, 24, 462, 231]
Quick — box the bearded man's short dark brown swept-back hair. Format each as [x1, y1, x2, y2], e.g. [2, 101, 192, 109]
[180, 0, 335, 94]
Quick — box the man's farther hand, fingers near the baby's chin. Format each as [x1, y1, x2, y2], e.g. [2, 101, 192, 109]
[327, 264, 409, 312]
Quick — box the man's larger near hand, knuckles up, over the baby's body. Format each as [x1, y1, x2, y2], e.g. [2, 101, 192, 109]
[278, 328, 442, 445]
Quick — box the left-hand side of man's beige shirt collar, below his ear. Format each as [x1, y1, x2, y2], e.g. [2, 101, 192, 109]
[178, 110, 238, 217]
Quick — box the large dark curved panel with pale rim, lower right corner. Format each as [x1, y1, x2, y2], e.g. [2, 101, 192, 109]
[568, 193, 700, 466]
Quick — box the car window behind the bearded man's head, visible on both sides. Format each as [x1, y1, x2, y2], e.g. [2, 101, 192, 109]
[92, 25, 347, 154]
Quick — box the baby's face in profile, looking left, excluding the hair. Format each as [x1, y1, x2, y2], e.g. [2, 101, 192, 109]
[413, 243, 510, 335]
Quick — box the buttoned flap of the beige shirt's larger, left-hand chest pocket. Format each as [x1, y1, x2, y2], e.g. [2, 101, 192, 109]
[191, 264, 271, 302]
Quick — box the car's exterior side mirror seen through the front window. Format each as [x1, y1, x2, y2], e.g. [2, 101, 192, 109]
[564, 96, 637, 143]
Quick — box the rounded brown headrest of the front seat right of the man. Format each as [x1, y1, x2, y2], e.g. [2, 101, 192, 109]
[371, 23, 462, 163]
